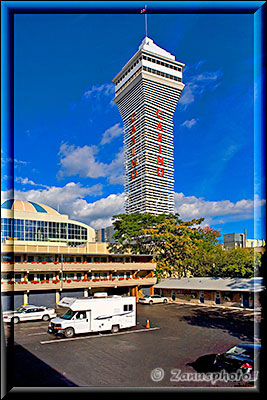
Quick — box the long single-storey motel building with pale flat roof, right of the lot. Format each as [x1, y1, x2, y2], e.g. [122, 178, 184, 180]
[154, 277, 265, 308]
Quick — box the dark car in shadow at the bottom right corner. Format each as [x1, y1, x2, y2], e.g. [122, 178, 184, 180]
[214, 343, 261, 373]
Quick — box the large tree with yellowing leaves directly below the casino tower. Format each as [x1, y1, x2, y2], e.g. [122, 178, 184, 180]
[110, 213, 219, 277]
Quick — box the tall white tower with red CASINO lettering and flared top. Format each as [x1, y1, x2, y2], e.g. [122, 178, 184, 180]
[113, 37, 185, 214]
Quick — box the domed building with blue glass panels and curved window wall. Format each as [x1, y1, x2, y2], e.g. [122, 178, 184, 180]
[1, 199, 95, 247]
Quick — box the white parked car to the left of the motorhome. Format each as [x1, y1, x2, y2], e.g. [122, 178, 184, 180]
[3, 305, 57, 324]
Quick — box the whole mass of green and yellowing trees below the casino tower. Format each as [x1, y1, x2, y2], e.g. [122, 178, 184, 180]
[109, 213, 261, 278]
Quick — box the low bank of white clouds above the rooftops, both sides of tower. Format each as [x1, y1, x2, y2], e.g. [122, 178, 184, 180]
[2, 182, 266, 229]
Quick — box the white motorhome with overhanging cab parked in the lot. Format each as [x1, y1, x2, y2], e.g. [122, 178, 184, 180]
[48, 292, 136, 338]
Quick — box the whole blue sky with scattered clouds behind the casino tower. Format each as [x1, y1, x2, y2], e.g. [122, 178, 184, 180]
[2, 6, 265, 242]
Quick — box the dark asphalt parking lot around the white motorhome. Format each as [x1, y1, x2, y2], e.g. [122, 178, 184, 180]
[2, 304, 259, 388]
